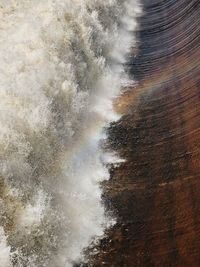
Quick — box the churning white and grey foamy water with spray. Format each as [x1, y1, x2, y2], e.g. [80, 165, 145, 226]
[0, 0, 140, 267]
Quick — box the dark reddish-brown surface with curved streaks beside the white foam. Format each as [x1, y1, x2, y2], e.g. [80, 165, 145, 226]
[92, 0, 200, 267]
